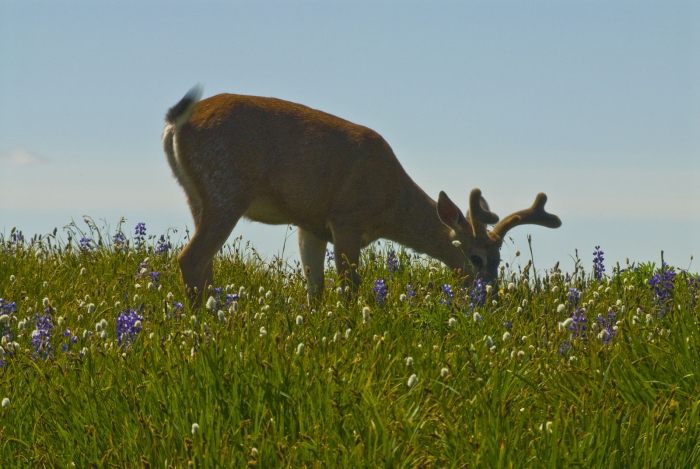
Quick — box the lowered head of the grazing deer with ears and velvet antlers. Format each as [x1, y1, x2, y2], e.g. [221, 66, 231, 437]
[437, 189, 561, 281]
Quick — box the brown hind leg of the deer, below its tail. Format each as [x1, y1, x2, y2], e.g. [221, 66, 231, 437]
[178, 205, 247, 309]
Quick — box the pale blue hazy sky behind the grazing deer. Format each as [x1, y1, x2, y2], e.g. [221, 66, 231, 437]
[0, 0, 700, 271]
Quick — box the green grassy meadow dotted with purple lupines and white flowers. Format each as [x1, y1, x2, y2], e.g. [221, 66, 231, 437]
[0, 219, 700, 468]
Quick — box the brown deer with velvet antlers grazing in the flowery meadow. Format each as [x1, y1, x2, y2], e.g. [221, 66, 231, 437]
[163, 87, 561, 307]
